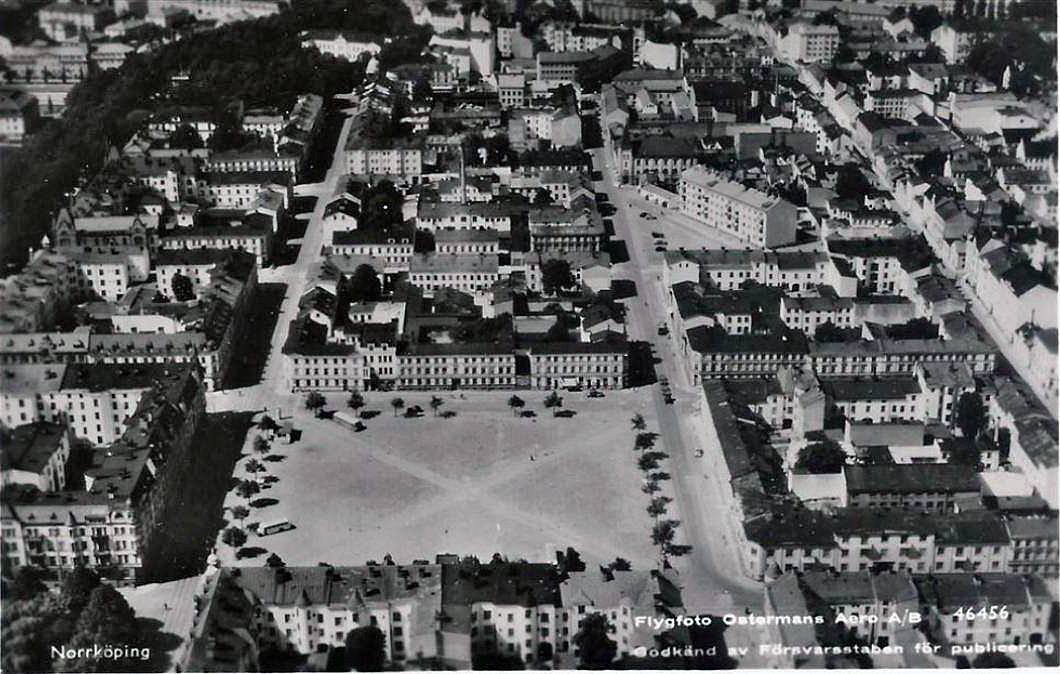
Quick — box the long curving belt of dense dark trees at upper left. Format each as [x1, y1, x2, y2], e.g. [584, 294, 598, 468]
[0, 0, 429, 268]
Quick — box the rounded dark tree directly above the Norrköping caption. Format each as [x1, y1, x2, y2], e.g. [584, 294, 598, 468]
[59, 589, 140, 672]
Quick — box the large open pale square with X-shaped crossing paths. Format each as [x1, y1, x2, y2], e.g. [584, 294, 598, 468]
[217, 389, 656, 568]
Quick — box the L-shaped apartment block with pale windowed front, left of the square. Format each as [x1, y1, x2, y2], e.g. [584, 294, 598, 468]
[0, 368, 206, 582]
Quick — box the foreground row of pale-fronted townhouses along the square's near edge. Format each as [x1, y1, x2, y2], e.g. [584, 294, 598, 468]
[184, 555, 681, 671]
